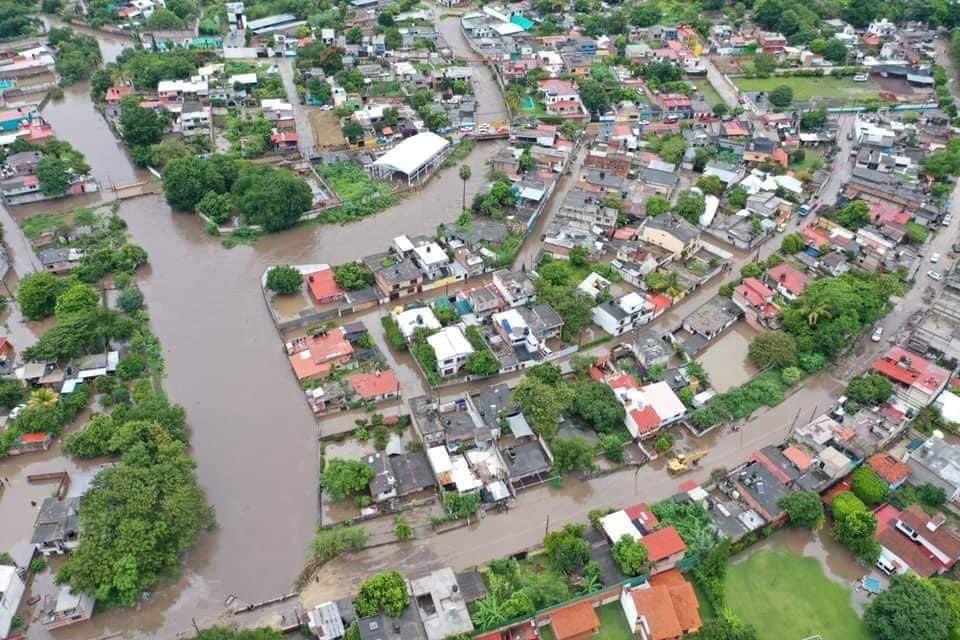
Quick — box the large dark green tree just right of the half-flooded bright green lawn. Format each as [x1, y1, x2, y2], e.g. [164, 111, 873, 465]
[863, 575, 958, 640]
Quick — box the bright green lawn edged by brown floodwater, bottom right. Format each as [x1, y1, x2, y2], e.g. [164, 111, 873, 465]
[724, 550, 870, 640]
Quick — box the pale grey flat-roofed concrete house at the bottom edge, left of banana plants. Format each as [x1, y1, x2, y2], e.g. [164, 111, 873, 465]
[410, 567, 473, 640]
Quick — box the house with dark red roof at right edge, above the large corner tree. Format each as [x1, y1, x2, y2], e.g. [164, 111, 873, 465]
[876, 505, 960, 578]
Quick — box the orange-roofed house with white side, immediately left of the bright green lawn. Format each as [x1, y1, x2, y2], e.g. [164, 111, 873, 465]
[620, 569, 703, 640]
